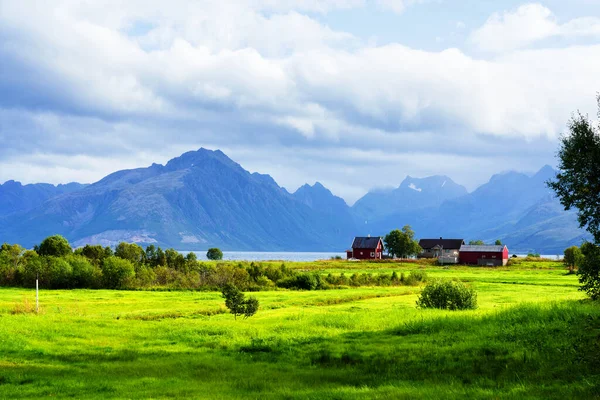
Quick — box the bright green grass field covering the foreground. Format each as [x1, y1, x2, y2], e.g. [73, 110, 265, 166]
[0, 261, 600, 399]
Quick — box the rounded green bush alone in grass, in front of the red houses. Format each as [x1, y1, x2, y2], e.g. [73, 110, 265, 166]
[417, 280, 477, 310]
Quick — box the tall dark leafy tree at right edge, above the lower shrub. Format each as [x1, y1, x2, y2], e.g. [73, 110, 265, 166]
[548, 95, 600, 244]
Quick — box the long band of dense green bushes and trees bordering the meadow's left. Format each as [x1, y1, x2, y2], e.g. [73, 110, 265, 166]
[0, 236, 426, 291]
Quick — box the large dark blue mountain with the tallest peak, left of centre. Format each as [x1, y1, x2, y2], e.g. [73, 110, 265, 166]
[0, 149, 352, 250]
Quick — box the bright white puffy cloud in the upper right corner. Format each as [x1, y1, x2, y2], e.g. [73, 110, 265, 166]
[471, 3, 600, 52]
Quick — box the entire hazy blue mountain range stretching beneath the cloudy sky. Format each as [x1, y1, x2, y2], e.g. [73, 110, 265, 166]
[0, 149, 588, 254]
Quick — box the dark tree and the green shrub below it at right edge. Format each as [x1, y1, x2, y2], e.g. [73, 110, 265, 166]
[548, 95, 600, 300]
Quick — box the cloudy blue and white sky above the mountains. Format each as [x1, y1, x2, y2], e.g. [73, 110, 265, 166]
[0, 0, 600, 204]
